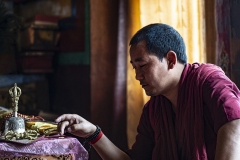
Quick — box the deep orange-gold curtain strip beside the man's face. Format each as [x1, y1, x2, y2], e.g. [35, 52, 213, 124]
[127, 0, 144, 147]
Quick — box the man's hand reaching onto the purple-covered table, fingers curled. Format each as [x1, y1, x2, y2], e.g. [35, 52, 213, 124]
[55, 114, 96, 138]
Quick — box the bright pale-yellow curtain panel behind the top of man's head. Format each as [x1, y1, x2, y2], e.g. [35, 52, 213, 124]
[140, 0, 206, 62]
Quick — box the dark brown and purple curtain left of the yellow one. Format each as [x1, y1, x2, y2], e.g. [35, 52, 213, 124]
[90, 0, 128, 160]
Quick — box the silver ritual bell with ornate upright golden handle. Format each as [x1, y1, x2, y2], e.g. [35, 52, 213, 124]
[3, 83, 25, 135]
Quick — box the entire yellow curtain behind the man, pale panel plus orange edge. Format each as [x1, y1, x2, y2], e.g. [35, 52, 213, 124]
[127, 0, 206, 146]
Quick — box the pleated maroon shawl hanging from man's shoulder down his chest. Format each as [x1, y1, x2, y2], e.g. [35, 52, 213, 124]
[176, 63, 224, 160]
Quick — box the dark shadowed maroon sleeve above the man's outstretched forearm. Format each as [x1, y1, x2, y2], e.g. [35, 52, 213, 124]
[126, 103, 154, 160]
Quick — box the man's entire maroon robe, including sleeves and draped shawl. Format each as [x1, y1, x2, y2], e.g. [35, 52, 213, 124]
[127, 63, 240, 160]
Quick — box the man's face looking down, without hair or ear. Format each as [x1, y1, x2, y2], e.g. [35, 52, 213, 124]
[130, 41, 170, 96]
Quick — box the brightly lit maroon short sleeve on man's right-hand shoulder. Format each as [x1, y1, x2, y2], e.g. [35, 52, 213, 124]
[203, 74, 240, 133]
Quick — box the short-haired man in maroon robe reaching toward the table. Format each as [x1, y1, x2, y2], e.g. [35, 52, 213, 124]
[56, 23, 240, 160]
